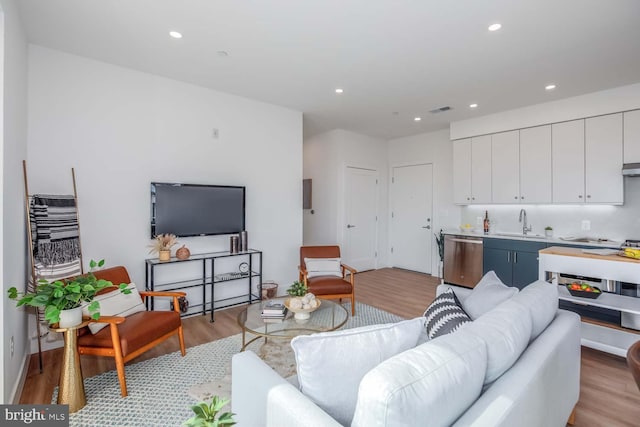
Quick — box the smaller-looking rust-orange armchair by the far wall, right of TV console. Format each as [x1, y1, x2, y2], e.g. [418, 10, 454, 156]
[298, 246, 357, 316]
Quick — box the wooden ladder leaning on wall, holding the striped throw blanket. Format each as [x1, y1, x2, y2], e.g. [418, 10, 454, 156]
[22, 160, 84, 373]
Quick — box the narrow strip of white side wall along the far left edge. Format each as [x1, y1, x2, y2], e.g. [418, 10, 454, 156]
[0, 0, 29, 403]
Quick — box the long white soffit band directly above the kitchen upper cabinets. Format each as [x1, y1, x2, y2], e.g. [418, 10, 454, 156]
[451, 83, 640, 139]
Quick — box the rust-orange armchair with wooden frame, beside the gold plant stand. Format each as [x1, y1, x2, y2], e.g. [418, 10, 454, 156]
[78, 267, 186, 397]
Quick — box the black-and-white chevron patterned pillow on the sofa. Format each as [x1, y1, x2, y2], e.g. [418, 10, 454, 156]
[424, 288, 471, 339]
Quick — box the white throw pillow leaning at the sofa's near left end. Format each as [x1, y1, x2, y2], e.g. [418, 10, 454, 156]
[291, 317, 424, 425]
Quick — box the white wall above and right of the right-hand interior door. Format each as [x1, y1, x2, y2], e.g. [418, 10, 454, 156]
[388, 130, 460, 275]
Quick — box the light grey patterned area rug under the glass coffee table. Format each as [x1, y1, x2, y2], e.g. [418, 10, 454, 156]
[52, 303, 402, 427]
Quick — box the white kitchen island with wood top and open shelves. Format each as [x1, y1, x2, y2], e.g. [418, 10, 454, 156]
[539, 246, 640, 357]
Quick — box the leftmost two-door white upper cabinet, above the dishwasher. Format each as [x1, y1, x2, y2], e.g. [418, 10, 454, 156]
[453, 135, 491, 205]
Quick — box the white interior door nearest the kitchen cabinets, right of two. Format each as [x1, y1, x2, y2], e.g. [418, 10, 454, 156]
[391, 164, 433, 274]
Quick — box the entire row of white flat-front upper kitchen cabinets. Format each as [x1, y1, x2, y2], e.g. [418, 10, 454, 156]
[453, 110, 628, 204]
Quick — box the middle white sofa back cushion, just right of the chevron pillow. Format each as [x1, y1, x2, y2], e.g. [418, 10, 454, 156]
[462, 300, 531, 385]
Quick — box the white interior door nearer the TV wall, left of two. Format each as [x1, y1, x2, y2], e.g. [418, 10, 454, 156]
[341, 167, 378, 271]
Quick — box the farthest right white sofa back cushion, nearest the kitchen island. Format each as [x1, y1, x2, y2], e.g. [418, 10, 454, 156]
[513, 280, 558, 341]
